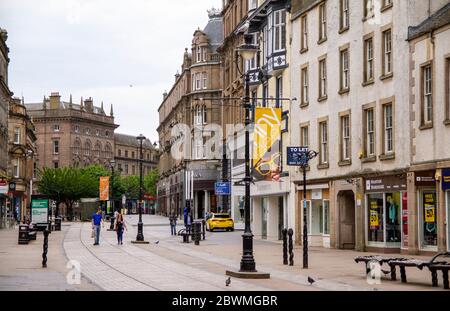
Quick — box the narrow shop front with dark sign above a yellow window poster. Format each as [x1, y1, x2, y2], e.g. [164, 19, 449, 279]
[415, 170, 438, 252]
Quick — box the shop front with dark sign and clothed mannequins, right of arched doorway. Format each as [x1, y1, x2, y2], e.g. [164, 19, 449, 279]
[365, 175, 408, 252]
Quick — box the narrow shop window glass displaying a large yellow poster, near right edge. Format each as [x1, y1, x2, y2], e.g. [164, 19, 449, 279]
[420, 191, 437, 247]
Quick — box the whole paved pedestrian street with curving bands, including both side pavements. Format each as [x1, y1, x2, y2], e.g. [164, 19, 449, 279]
[0, 215, 439, 291]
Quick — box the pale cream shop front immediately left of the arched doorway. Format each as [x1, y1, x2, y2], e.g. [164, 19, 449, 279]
[297, 184, 330, 248]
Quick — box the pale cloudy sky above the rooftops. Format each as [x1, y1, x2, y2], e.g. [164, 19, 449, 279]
[0, 0, 222, 141]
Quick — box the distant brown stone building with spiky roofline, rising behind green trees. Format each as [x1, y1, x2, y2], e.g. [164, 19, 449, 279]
[26, 93, 118, 169]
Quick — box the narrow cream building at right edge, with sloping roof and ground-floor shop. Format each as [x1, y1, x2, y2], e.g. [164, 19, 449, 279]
[408, 4, 450, 253]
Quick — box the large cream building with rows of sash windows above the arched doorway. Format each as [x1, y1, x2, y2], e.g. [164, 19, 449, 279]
[290, 0, 448, 253]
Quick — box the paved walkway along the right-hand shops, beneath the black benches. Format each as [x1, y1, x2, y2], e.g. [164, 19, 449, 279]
[126, 215, 442, 291]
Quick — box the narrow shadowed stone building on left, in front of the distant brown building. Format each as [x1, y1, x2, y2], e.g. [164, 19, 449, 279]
[8, 98, 37, 222]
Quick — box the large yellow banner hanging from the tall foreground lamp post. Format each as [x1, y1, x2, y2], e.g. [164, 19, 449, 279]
[253, 107, 282, 181]
